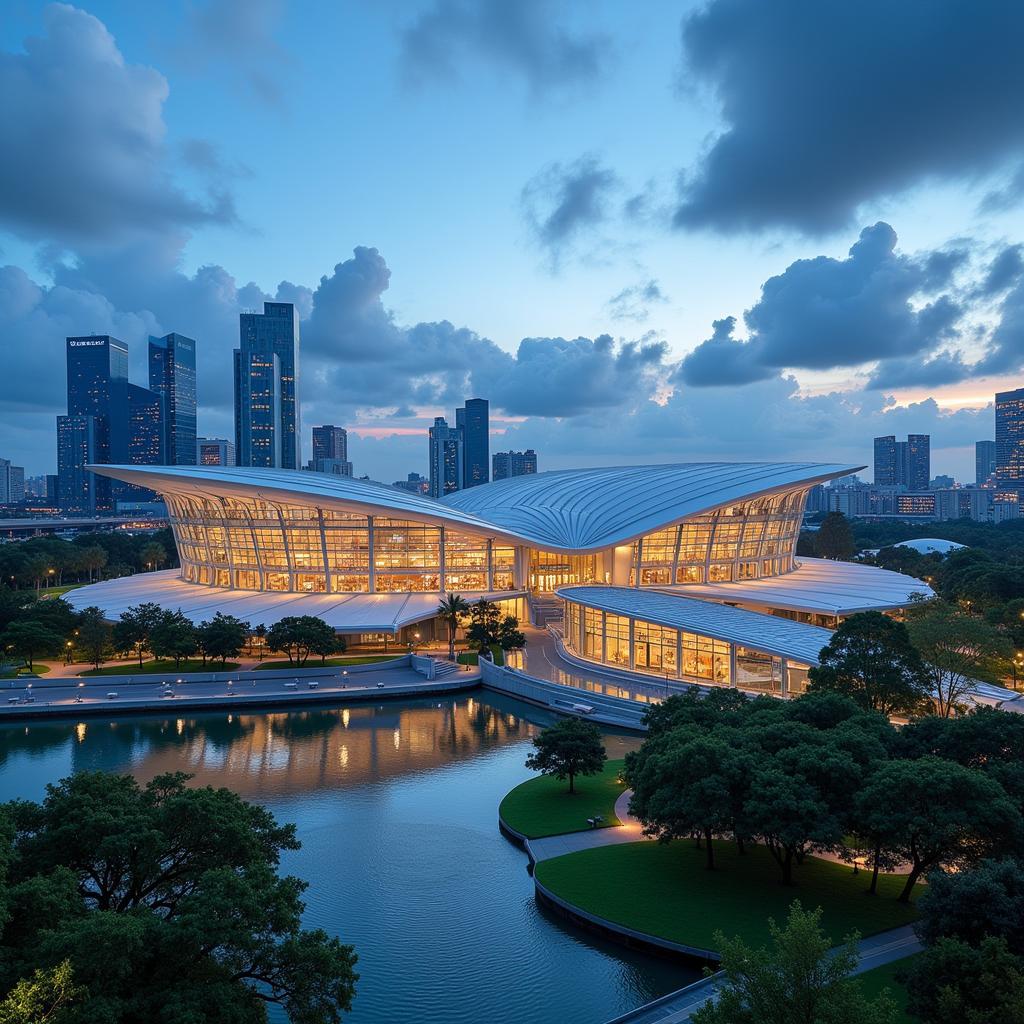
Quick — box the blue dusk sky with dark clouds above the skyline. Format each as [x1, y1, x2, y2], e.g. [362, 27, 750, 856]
[0, 0, 1024, 481]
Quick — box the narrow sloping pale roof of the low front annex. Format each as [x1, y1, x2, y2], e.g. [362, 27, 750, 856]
[558, 587, 831, 665]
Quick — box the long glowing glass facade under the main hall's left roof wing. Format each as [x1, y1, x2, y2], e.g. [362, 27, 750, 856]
[166, 494, 515, 594]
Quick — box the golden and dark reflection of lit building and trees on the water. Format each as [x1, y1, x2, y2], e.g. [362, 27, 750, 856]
[0, 693, 550, 799]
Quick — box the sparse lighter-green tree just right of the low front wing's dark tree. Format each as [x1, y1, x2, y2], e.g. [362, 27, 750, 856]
[907, 601, 1013, 718]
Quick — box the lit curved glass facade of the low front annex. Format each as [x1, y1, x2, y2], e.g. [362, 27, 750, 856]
[563, 601, 809, 693]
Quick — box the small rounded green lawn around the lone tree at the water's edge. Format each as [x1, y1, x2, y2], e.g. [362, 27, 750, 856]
[498, 761, 626, 839]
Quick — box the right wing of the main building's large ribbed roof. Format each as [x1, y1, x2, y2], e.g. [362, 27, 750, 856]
[441, 462, 863, 551]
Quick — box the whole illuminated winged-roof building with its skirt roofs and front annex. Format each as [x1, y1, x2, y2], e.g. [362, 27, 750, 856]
[68, 463, 930, 699]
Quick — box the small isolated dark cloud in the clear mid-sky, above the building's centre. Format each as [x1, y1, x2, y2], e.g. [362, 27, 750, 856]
[521, 155, 618, 261]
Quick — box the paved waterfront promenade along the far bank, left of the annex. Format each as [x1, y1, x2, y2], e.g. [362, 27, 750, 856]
[0, 655, 480, 722]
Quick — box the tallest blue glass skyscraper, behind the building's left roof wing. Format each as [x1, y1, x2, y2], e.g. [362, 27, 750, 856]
[234, 302, 302, 469]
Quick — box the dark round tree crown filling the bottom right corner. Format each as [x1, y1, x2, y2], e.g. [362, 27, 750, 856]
[906, 937, 1024, 1024]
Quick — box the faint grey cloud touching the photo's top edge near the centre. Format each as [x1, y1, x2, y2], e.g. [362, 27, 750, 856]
[401, 0, 610, 96]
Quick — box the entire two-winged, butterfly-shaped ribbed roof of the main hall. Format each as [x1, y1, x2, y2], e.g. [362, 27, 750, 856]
[89, 462, 863, 551]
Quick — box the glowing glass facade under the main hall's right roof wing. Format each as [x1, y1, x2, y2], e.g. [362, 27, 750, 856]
[626, 489, 807, 587]
